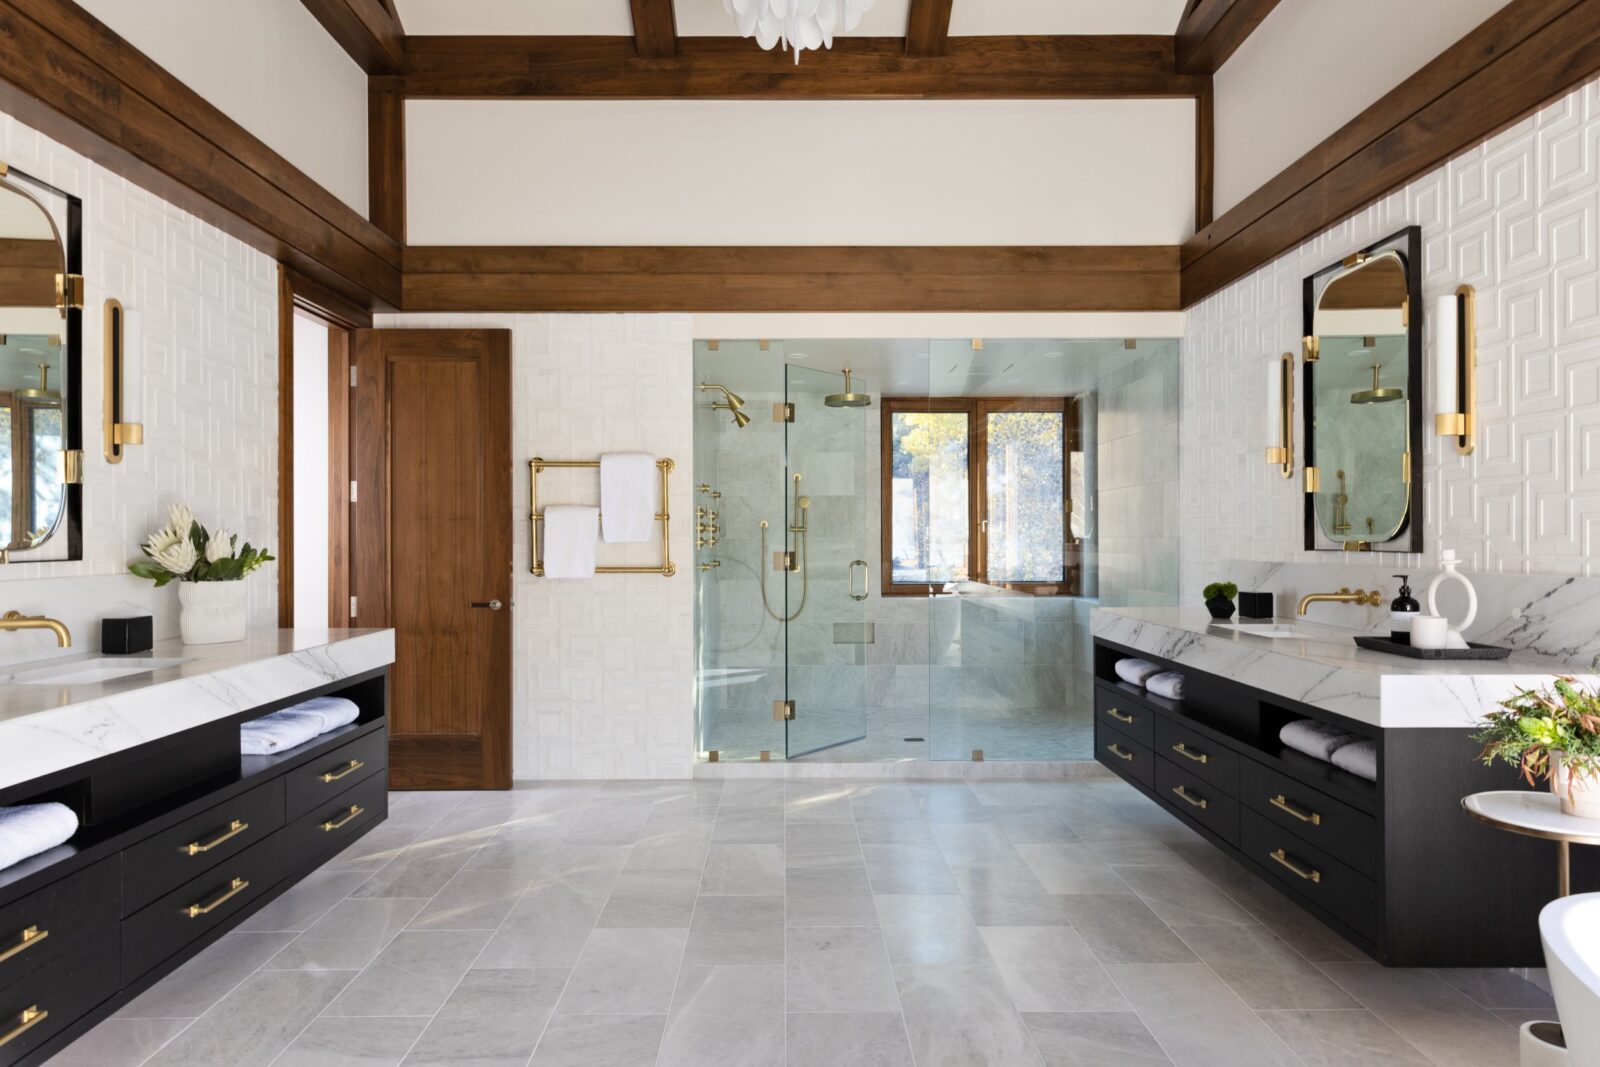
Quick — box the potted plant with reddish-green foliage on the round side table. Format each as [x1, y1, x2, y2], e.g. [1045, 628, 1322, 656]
[1472, 678, 1600, 819]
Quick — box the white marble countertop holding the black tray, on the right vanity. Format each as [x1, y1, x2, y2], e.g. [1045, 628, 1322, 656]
[1093, 608, 1600, 728]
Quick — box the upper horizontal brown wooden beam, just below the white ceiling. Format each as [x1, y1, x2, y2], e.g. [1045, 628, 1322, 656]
[405, 35, 1206, 99]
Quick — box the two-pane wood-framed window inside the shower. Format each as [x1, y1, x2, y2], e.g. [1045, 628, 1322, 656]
[880, 397, 1083, 597]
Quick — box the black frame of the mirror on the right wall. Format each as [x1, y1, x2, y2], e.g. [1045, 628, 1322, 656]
[1301, 226, 1424, 552]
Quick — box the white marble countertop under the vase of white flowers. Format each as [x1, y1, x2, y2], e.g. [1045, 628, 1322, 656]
[0, 629, 395, 787]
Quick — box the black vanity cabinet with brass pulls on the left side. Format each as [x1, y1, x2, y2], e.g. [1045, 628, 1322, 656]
[0, 669, 389, 1067]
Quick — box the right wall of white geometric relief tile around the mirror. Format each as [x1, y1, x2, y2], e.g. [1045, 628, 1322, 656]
[1181, 82, 1600, 667]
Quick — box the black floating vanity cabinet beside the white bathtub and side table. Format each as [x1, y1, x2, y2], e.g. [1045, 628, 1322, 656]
[1094, 638, 1555, 966]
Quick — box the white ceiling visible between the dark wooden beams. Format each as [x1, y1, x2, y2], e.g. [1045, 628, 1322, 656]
[395, 0, 1184, 37]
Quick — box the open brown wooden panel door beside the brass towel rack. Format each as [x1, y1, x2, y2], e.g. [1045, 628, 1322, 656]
[350, 330, 512, 789]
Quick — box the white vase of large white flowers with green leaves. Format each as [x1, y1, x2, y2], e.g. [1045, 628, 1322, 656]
[128, 504, 274, 645]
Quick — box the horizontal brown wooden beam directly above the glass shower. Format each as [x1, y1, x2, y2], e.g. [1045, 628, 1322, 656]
[405, 245, 1179, 312]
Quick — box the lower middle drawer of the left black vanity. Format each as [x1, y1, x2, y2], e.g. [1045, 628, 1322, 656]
[122, 832, 285, 984]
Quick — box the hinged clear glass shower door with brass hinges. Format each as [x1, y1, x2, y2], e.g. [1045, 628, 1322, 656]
[780, 365, 877, 760]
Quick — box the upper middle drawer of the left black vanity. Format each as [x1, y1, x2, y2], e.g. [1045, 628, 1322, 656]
[122, 781, 283, 915]
